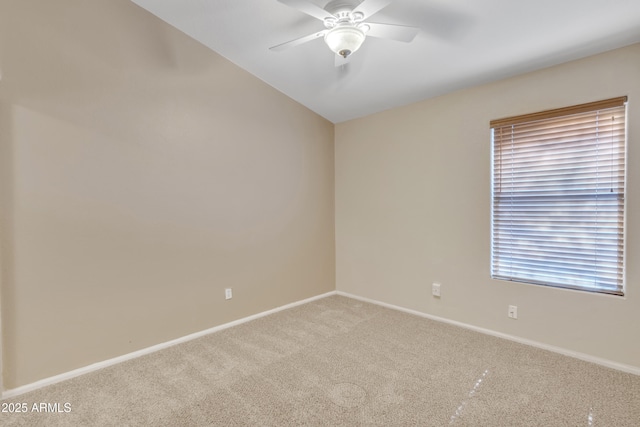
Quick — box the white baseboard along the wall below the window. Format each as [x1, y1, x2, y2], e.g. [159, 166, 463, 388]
[336, 291, 640, 375]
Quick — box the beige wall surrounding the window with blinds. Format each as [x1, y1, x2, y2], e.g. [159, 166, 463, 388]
[335, 44, 640, 368]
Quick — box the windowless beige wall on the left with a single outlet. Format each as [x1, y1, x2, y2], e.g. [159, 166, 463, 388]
[0, 0, 335, 388]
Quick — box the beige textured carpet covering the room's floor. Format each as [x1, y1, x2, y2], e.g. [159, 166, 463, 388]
[0, 296, 640, 427]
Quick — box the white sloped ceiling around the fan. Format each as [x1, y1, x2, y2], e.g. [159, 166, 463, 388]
[132, 0, 640, 123]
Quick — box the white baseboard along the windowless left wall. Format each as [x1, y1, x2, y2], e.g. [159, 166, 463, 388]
[2, 291, 336, 399]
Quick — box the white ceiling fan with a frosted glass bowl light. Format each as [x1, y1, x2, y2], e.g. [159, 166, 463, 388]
[270, 0, 419, 59]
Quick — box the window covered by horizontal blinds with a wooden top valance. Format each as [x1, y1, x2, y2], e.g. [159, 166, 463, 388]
[491, 97, 627, 295]
